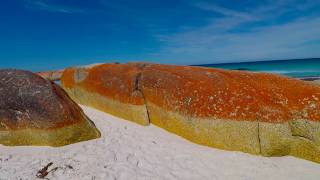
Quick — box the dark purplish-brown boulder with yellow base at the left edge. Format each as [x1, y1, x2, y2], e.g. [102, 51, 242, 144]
[0, 70, 100, 146]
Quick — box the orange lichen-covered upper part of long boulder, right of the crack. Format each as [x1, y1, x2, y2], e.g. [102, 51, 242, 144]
[141, 65, 320, 123]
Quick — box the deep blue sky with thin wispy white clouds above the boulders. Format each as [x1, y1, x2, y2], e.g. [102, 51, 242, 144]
[0, 0, 320, 71]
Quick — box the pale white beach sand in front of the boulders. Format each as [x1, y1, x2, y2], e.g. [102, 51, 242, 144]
[0, 107, 320, 180]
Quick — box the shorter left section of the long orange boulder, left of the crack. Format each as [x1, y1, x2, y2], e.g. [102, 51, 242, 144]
[61, 64, 149, 125]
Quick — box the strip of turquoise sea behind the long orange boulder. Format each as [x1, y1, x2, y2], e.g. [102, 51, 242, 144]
[197, 58, 320, 78]
